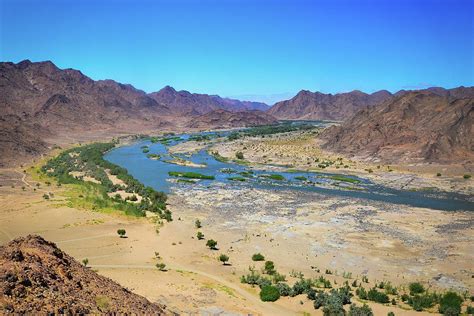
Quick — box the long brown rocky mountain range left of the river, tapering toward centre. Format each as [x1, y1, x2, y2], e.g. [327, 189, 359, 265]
[0, 60, 270, 167]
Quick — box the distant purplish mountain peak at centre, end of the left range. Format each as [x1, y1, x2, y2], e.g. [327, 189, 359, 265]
[149, 86, 268, 116]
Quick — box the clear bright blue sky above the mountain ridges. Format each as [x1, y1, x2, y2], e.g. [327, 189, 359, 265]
[0, 0, 474, 103]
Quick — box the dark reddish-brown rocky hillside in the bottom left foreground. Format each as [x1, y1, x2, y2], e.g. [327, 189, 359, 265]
[0, 235, 168, 315]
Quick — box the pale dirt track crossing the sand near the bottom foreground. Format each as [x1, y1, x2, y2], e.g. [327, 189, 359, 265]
[89, 264, 293, 315]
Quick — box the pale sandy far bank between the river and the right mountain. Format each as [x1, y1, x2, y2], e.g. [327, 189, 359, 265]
[210, 131, 474, 196]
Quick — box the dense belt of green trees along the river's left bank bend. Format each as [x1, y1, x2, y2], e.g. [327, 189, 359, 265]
[40, 142, 168, 221]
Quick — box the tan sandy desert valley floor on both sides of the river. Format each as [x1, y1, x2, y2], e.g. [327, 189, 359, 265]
[0, 125, 474, 315]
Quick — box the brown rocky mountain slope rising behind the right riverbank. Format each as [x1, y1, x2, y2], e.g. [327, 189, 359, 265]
[320, 87, 474, 163]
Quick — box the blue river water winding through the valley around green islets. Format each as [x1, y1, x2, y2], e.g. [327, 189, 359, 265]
[104, 132, 474, 211]
